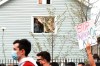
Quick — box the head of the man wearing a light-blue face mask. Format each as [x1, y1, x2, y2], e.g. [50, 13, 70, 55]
[12, 39, 31, 60]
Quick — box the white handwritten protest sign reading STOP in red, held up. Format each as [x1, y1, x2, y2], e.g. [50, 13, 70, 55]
[75, 21, 96, 49]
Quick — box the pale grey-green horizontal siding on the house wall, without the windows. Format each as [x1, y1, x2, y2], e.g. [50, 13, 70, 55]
[0, 0, 86, 58]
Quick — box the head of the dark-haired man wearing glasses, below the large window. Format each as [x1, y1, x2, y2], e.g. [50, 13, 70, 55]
[37, 51, 51, 64]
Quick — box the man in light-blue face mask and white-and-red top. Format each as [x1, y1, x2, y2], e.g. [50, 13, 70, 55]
[12, 39, 37, 66]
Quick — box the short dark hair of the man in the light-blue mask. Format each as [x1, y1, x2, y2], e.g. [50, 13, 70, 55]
[13, 39, 31, 56]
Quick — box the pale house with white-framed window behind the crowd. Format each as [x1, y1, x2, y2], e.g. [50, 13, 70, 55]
[0, 0, 86, 59]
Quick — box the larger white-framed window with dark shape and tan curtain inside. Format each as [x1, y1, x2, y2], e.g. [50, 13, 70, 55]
[32, 16, 55, 33]
